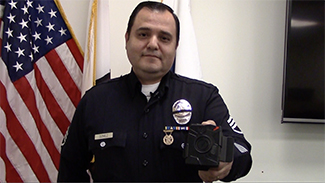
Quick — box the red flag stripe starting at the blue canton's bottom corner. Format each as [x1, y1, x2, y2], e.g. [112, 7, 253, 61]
[14, 77, 60, 169]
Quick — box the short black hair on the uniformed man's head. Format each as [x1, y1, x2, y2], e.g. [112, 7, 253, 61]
[126, 1, 180, 44]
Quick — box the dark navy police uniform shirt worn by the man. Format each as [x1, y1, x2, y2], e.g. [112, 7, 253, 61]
[58, 71, 252, 182]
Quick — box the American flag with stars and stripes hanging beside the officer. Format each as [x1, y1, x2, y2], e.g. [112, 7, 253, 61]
[0, 0, 83, 182]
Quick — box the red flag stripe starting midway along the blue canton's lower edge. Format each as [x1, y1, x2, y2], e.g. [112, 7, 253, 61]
[34, 64, 70, 134]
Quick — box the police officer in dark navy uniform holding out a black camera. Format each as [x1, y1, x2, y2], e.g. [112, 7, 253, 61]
[58, 1, 252, 182]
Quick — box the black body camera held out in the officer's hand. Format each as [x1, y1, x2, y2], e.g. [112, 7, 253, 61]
[184, 124, 234, 170]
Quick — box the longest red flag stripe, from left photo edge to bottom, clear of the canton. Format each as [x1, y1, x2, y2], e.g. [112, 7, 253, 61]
[0, 82, 50, 182]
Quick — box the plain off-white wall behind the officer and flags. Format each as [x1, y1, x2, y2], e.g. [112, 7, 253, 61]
[60, 0, 325, 182]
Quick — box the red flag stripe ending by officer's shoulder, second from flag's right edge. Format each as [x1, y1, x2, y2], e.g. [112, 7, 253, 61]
[45, 50, 81, 107]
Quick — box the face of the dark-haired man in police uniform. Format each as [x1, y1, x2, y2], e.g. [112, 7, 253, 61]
[125, 8, 177, 84]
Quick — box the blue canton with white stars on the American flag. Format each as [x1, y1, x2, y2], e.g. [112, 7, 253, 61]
[0, 0, 72, 82]
